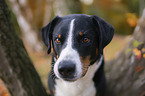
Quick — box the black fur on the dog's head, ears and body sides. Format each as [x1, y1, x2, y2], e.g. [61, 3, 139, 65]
[41, 14, 114, 96]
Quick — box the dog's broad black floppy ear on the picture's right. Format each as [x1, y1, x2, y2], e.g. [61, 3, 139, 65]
[92, 15, 114, 53]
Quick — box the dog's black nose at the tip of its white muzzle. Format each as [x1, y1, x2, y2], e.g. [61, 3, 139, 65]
[58, 61, 75, 78]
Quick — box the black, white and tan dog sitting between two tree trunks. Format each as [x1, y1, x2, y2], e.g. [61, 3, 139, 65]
[41, 14, 114, 96]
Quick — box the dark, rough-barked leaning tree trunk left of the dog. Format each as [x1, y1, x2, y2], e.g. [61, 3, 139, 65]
[0, 0, 48, 96]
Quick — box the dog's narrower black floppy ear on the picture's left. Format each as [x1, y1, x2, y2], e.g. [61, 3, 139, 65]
[41, 16, 59, 54]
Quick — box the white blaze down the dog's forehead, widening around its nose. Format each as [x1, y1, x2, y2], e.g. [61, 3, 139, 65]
[54, 19, 82, 78]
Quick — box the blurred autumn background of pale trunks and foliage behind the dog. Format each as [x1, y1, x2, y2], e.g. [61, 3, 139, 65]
[0, 0, 145, 96]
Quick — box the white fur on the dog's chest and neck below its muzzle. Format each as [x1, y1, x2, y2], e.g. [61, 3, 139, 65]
[55, 64, 100, 96]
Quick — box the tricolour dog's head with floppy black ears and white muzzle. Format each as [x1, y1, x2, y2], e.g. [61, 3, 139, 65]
[41, 14, 114, 81]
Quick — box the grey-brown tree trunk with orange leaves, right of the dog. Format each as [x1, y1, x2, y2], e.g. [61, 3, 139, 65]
[106, 9, 145, 96]
